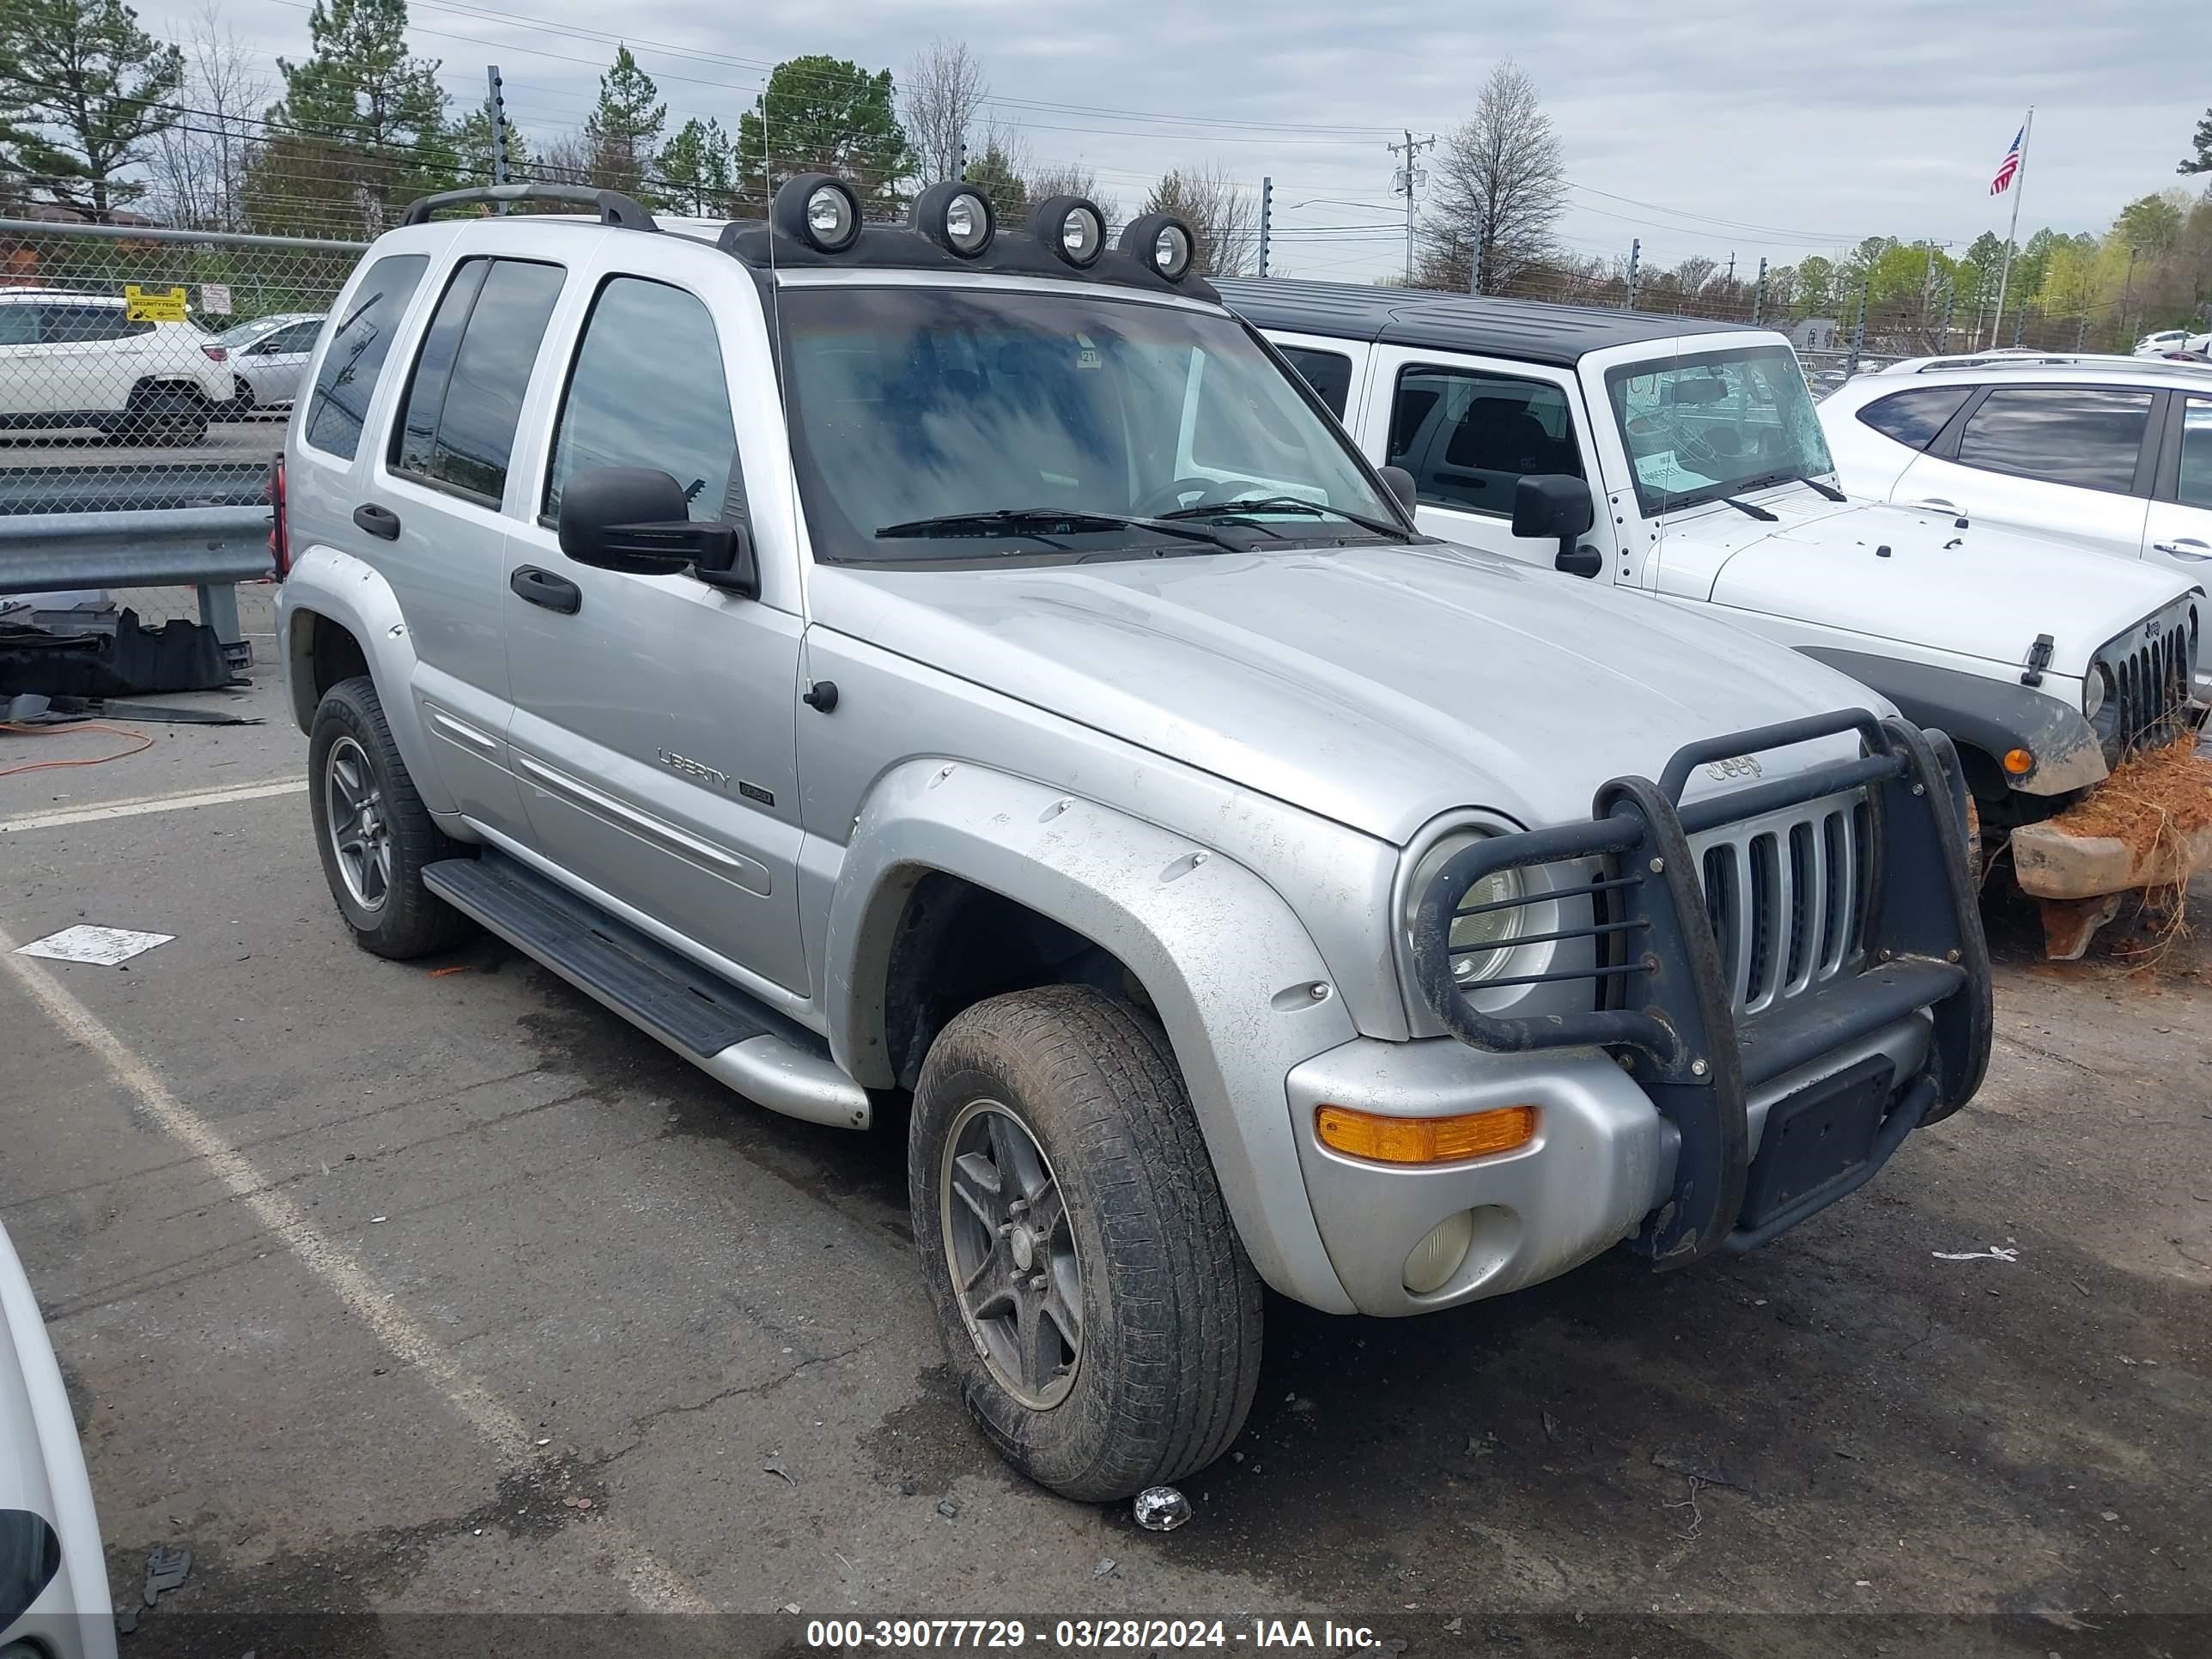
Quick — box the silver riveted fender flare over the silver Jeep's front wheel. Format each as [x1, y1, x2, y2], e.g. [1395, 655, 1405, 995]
[823, 759, 1358, 1314]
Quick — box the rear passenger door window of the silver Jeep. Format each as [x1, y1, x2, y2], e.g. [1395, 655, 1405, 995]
[392, 258, 566, 507]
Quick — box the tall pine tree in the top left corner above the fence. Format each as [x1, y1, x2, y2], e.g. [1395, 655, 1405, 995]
[0, 0, 184, 223]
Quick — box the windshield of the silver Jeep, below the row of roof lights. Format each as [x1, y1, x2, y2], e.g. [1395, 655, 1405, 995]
[776, 285, 1402, 562]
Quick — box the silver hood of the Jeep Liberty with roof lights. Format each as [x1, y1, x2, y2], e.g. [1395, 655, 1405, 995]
[810, 544, 1889, 842]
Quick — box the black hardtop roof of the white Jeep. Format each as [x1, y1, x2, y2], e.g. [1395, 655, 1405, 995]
[1214, 276, 1752, 368]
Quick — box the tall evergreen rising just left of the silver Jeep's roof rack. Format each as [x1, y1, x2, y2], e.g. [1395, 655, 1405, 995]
[246, 0, 458, 237]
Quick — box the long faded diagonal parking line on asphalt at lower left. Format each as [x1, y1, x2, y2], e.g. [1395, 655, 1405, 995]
[0, 928, 714, 1613]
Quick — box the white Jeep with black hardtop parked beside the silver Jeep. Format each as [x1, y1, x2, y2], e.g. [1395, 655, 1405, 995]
[1218, 281, 2212, 957]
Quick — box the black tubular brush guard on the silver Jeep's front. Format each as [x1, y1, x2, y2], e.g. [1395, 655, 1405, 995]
[1413, 710, 1990, 1267]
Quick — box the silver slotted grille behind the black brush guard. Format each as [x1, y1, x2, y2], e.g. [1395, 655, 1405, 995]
[1690, 796, 1874, 1015]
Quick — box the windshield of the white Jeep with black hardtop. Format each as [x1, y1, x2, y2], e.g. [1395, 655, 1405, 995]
[1606, 345, 1836, 514]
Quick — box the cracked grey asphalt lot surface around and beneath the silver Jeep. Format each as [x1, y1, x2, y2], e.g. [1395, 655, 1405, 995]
[0, 604, 2212, 1659]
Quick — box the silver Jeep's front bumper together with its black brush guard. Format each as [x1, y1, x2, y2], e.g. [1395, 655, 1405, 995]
[1287, 710, 1990, 1314]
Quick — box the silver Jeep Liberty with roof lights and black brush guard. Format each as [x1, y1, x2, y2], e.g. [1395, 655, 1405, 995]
[272, 175, 1990, 1500]
